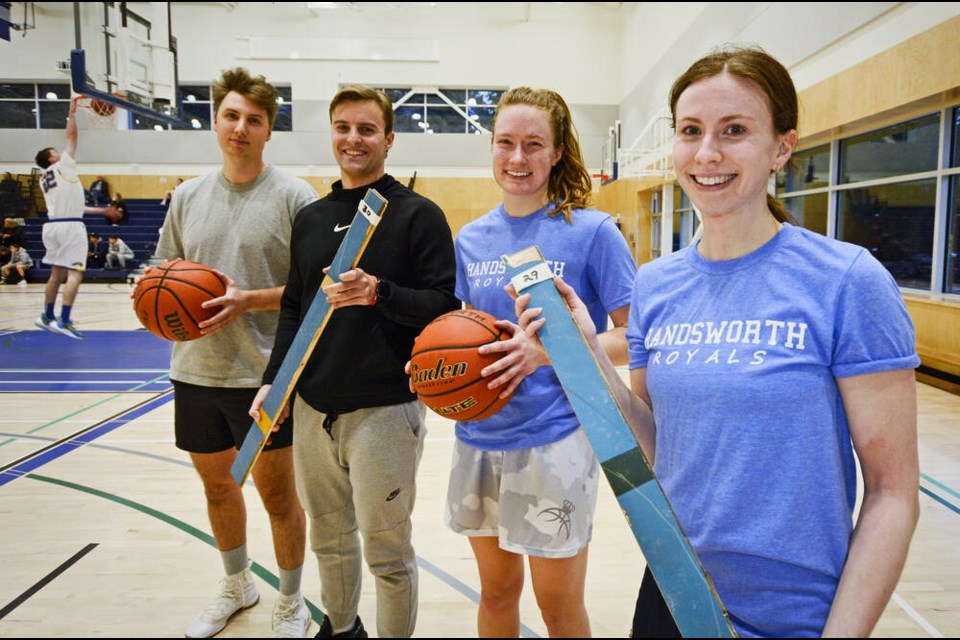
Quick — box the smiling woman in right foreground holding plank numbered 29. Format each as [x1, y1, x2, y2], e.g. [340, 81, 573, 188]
[518, 48, 919, 637]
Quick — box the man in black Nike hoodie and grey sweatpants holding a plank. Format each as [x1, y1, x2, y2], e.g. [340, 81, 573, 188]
[251, 86, 460, 638]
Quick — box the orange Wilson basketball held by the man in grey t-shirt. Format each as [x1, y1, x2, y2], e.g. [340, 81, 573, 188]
[133, 258, 226, 342]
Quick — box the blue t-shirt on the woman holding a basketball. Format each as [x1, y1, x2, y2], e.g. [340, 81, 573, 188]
[455, 205, 636, 451]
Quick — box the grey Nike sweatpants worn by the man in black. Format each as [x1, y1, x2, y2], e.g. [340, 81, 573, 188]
[293, 398, 427, 638]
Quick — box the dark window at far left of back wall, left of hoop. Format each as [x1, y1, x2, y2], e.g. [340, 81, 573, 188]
[0, 82, 70, 129]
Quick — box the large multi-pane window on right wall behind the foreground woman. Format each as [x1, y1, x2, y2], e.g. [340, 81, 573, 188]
[776, 108, 960, 294]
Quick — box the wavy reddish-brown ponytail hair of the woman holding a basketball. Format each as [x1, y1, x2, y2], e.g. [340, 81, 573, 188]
[493, 87, 593, 222]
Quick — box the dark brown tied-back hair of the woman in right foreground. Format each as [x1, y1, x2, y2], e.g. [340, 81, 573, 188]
[670, 46, 800, 224]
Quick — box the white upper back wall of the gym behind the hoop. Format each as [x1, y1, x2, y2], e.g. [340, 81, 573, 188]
[0, 2, 620, 175]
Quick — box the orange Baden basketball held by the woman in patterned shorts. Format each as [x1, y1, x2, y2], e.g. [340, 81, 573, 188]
[410, 309, 511, 420]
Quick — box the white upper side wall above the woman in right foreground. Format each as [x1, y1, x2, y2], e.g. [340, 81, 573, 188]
[620, 2, 960, 154]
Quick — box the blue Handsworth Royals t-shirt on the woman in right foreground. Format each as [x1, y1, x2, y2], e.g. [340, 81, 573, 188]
[627, 224, 919, 637]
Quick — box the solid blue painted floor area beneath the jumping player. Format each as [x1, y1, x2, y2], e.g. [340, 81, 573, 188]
[0, 331, 173, 393]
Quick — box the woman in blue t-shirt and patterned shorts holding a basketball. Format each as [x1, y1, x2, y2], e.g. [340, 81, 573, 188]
[446, 87, 636, 638]
